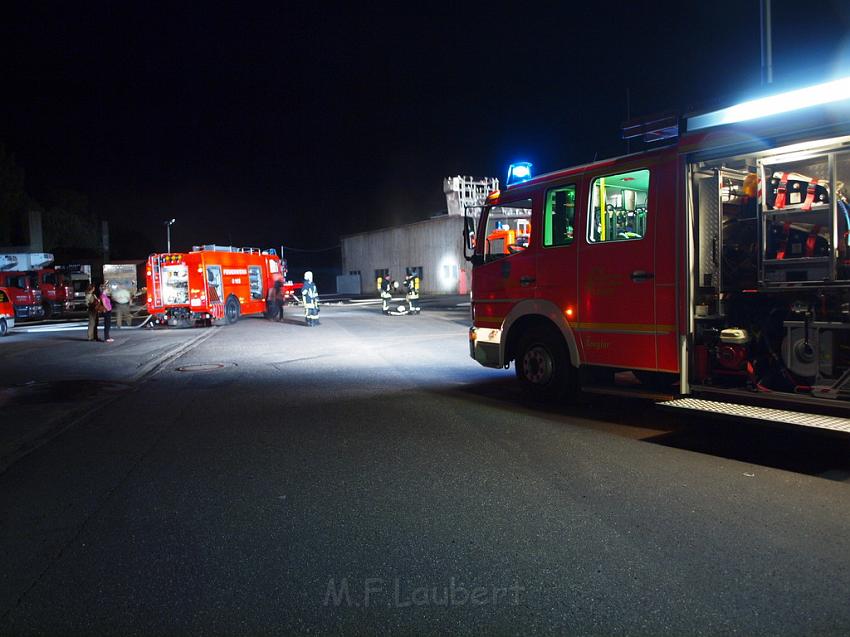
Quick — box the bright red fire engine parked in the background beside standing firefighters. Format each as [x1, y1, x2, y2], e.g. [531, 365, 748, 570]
[145, 245, 286, 325]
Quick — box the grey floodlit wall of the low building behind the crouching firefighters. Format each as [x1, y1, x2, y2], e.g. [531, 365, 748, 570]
[342, 215, 469, 294]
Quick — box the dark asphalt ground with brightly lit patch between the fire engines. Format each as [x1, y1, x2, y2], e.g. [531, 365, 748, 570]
[0, 306, 850, 635]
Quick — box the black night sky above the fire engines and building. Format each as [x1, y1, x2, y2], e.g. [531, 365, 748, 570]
[0, 0, 850, 259]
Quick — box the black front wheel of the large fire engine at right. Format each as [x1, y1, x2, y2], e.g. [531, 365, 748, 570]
[514, 327, 577, 402]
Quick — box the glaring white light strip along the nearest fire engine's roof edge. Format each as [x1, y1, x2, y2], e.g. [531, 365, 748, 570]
[688, 77, 850, 131]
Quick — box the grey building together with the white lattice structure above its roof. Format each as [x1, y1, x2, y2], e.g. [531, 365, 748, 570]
[341, 177, 499, 294]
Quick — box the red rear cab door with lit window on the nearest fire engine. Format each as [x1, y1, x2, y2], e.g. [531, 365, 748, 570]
[576, 169, 674, 370]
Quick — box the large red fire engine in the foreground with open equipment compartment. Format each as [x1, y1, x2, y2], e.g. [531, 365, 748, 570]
[464, 78, 850, 432]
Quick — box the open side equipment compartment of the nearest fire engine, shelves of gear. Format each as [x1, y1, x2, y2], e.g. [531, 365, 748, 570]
[690, 138, 850, 400]
